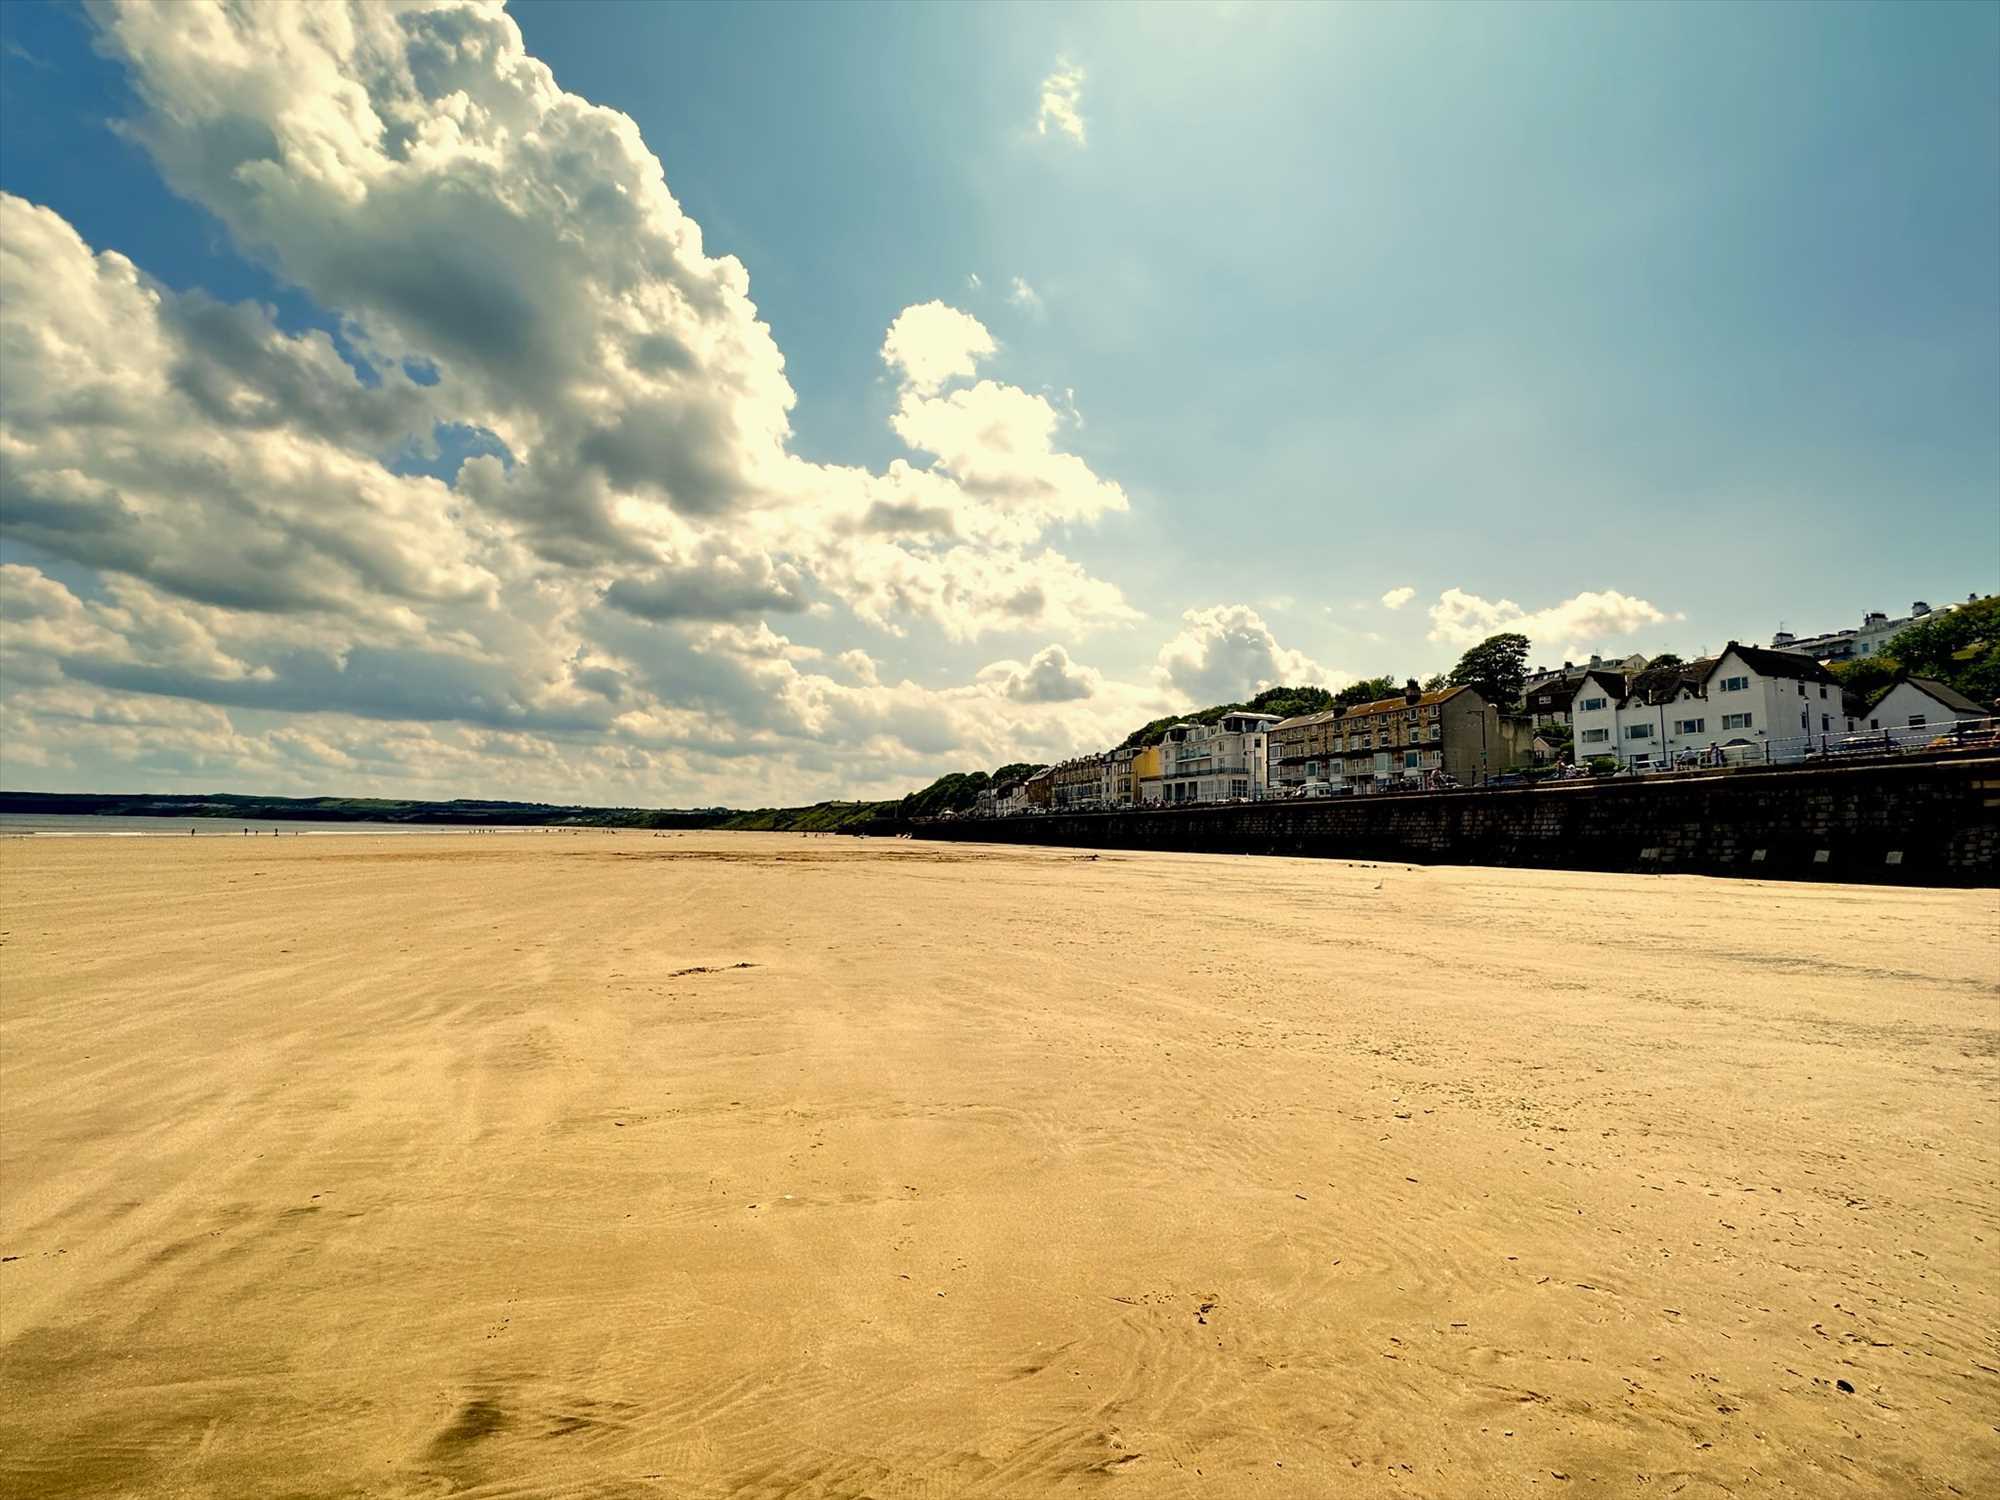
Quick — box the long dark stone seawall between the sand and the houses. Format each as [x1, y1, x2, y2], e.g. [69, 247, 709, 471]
[910, 756, 2000, 886]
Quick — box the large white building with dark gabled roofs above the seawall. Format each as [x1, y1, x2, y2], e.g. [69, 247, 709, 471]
[1570, 640, 1854, 768]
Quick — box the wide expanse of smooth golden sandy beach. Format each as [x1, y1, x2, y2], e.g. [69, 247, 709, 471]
[0, 832, 2000, 1500]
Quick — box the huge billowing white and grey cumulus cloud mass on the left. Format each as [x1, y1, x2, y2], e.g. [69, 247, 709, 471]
[0, 0, 1160, 802]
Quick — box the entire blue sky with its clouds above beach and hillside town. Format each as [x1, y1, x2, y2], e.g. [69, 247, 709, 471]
[0, 4, 2000, 802]
